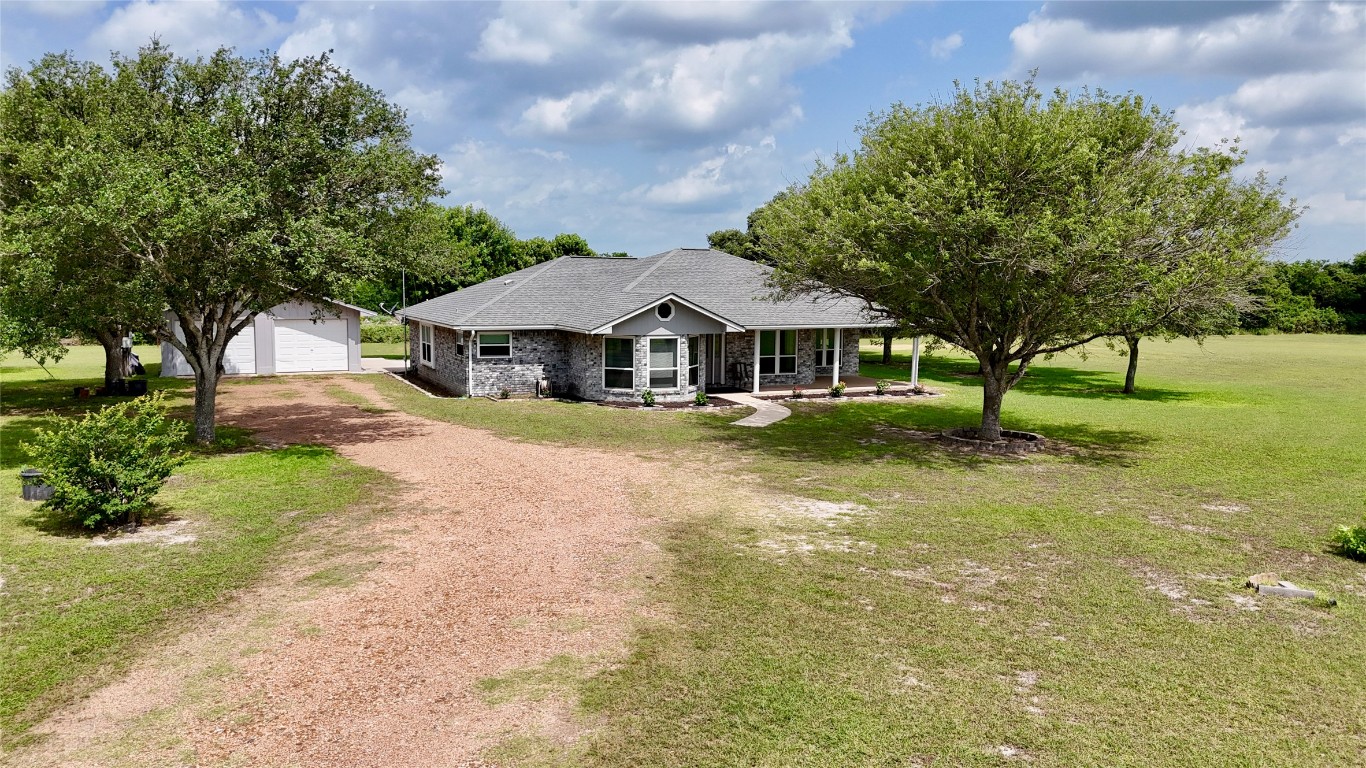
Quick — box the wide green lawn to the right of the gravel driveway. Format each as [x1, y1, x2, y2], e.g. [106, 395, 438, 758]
[382, 336, 1366, 767]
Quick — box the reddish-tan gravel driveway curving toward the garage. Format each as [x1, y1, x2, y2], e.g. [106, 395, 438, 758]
[16, 379, 661, 767]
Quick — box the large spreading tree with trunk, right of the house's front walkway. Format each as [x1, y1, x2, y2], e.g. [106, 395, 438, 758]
[757, 82, 1296, 439]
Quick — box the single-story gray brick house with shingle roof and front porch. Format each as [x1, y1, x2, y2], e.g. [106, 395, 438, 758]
[399, 249, 892, 402]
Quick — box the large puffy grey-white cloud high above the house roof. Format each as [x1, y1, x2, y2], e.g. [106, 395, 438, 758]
[474, 3, 861, 145]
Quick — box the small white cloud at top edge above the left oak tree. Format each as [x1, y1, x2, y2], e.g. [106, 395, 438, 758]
[87, 0, 284, 56]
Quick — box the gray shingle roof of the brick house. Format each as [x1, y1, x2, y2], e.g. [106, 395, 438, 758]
[399, 249, 888, 333]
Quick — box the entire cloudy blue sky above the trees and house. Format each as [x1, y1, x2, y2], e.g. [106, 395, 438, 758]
[0, 0, 1366, 260]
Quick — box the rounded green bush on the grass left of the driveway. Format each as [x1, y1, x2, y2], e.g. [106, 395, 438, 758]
[29, 392, 189, 529]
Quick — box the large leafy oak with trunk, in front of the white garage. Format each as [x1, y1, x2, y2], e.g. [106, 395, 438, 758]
[5, 41, 440, 441]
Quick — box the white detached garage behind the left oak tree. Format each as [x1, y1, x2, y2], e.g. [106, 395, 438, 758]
[161, 296, 374, 376]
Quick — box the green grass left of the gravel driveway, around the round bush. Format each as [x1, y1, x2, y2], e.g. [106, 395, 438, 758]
[0, 347, 382, 754]
